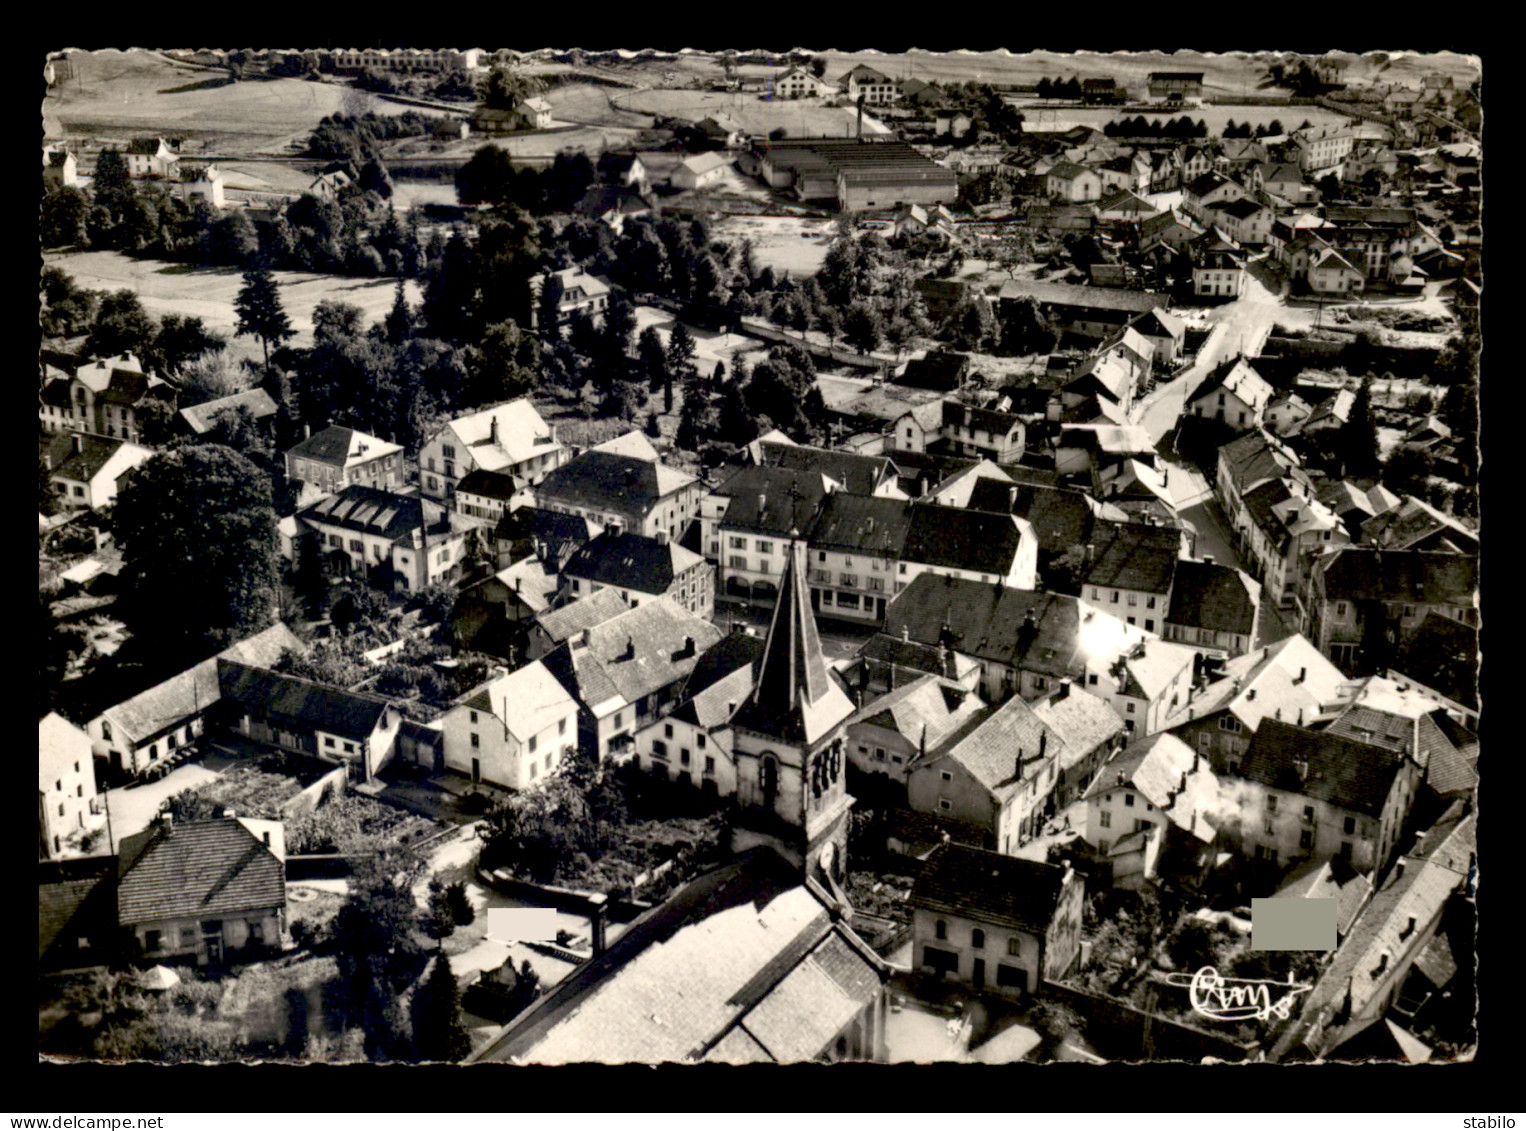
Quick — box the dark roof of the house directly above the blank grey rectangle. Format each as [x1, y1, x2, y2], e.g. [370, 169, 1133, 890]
[1239, 719, 1402, 817]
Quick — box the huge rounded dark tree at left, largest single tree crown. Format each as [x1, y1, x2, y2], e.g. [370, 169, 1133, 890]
[111, 444, 279, 658]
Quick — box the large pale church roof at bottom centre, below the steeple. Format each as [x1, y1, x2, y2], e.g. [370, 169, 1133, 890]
[472, 849, 887, 1064]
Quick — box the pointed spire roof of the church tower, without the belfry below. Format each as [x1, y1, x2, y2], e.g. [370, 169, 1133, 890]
[734, 531, 853, 746]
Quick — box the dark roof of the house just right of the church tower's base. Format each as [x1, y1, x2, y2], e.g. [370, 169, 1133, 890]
[911, 844, 1068, 936]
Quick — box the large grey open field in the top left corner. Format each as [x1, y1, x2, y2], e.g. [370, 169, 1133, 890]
[43, 50, 451, 153]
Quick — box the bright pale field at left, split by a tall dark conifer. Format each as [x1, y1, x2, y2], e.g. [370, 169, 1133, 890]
[43, 252, 423, 346]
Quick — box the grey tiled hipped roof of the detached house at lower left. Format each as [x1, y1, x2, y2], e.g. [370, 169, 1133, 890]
[116, 818, 285, 926]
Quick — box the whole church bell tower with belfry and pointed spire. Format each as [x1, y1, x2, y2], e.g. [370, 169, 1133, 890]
[731, 531, 853, 887]
